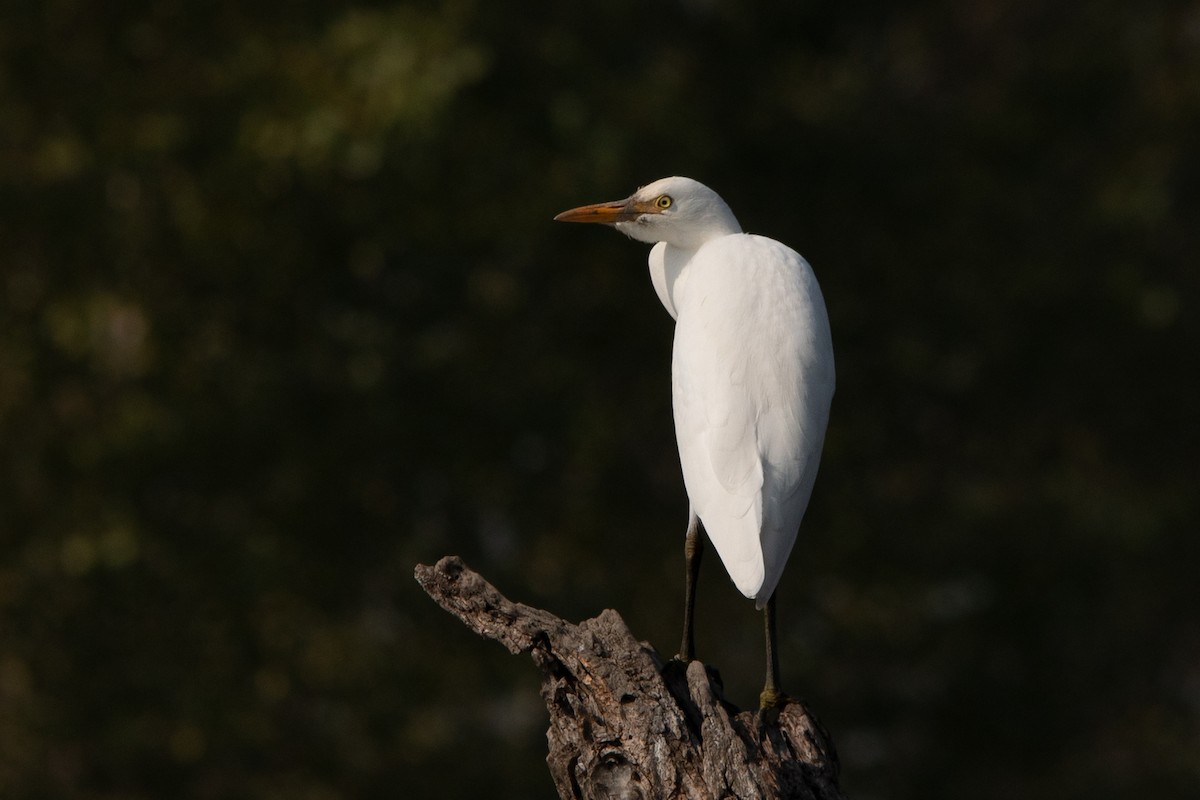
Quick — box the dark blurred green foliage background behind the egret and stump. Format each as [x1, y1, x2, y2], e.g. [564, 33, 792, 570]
[0, 0, 1200, 800]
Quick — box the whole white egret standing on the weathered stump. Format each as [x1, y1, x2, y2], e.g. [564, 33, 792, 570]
[554, 178, 834, 708]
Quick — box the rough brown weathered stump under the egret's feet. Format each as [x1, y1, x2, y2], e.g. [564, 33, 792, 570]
[416, 555, 842, 800]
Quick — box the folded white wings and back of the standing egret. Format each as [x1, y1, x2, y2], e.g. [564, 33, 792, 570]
[672, 234, 834, 607]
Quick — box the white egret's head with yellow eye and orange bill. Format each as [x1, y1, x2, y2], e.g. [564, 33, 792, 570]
[554, 178, 742, 249]
